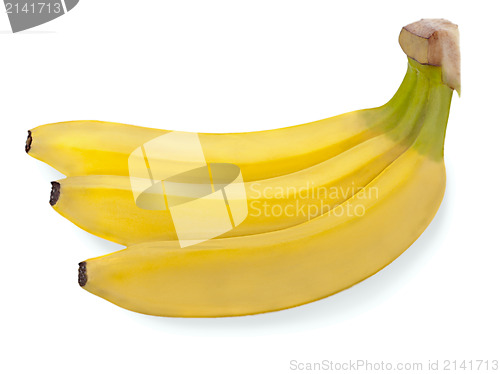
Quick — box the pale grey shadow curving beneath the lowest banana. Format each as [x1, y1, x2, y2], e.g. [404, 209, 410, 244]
[117, 170, 454, 337]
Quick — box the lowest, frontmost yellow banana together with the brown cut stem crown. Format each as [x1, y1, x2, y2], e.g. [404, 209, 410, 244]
[78, 20, 460, 317]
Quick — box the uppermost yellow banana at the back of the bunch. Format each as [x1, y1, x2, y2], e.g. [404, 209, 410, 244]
[25, 65, 416, 181]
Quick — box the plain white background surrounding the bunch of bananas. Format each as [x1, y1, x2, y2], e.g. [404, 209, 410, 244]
[0, 0, 500, 374]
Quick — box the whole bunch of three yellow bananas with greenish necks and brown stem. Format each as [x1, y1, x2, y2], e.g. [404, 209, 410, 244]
[26, 20, 460, 317]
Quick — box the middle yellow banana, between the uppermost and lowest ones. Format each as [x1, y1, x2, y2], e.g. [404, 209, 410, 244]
[51, 59, 430, 245]
